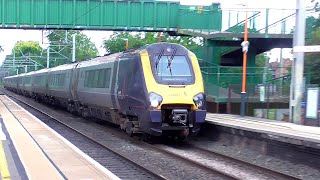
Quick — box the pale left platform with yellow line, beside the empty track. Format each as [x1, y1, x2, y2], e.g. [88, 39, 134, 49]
[0, 95, 119, 179]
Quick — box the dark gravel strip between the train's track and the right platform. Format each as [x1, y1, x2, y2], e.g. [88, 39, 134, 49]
[190, 137, 320, 180]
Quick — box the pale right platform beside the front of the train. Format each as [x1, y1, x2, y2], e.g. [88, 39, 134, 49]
[206, 113, 320, 149]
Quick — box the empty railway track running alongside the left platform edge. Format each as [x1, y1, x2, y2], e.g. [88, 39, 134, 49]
[1, 93, 166, 180]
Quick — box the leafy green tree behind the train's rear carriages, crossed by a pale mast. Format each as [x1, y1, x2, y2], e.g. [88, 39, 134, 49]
[48, 30, 98, 67]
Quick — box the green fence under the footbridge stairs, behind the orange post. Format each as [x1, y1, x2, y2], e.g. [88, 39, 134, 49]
[199, 60, 300, 102]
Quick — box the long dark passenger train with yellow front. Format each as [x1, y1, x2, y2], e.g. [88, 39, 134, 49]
[4, 43, 206, 137]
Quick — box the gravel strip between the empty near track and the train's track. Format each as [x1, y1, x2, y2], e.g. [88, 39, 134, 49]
[6, 91, 230, 180]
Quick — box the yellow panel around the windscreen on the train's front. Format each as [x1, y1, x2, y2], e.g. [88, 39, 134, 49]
[140, 50, 204, 110]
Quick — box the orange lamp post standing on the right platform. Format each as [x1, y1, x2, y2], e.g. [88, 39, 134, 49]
[240, 5, 250, 116]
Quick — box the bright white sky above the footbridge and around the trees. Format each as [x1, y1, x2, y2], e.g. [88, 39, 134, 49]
[0, 0, 304, 64]
